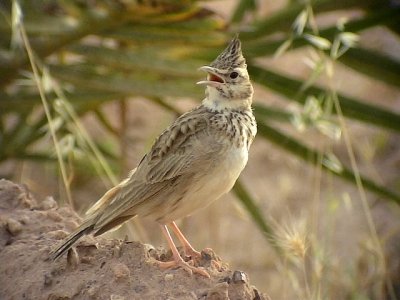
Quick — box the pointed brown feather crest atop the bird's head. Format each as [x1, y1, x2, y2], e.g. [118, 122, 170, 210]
[210, 35, 246, 70]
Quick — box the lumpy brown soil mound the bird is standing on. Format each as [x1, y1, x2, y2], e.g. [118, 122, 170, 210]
[0, 180, 267, 300]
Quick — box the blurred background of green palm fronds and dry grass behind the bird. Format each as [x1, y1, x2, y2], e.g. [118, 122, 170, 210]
[0, 0, 400, 299]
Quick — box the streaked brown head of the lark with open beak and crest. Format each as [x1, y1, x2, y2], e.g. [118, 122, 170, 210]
[197, 36, 253, 109]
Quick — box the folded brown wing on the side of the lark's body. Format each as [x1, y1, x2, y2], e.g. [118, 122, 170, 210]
[95, 107, 218, 229]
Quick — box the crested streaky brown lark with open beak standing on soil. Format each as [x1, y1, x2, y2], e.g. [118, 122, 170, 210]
[49, 35, 257, 277]
